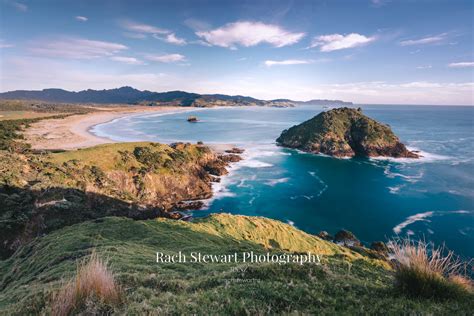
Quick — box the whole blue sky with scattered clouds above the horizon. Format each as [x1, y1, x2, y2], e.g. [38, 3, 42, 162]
[0, 0, 474, 105]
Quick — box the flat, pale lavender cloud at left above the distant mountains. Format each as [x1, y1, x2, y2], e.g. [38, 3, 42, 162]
[31, 38, 128, 59]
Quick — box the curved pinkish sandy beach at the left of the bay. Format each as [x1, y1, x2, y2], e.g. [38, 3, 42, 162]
[24, 106, 185, 150]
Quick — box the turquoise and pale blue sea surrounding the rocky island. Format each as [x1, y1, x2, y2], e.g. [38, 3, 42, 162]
[93, 105, 474, 257]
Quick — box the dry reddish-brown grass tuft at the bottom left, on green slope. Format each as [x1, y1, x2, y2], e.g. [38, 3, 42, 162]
[51, 252, 121, 316]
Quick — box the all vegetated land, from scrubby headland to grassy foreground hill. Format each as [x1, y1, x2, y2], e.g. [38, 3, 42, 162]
[0, 105, 474, 315]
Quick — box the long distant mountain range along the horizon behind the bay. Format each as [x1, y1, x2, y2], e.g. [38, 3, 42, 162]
[0, 87, 352, 107]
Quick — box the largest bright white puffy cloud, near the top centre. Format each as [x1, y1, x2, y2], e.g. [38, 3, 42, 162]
[196, 21, 305, 49]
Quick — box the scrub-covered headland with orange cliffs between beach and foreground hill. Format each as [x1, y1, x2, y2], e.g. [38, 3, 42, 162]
[0, 143, 223, 257]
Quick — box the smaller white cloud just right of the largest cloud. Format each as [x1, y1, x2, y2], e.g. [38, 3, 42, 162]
[310, 33, 376, 52]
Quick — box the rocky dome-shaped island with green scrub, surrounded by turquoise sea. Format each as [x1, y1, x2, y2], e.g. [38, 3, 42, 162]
[276, 107, 420, 158]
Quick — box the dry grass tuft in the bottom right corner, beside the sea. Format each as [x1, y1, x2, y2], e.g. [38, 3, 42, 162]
[389, 239, 473, 298]
